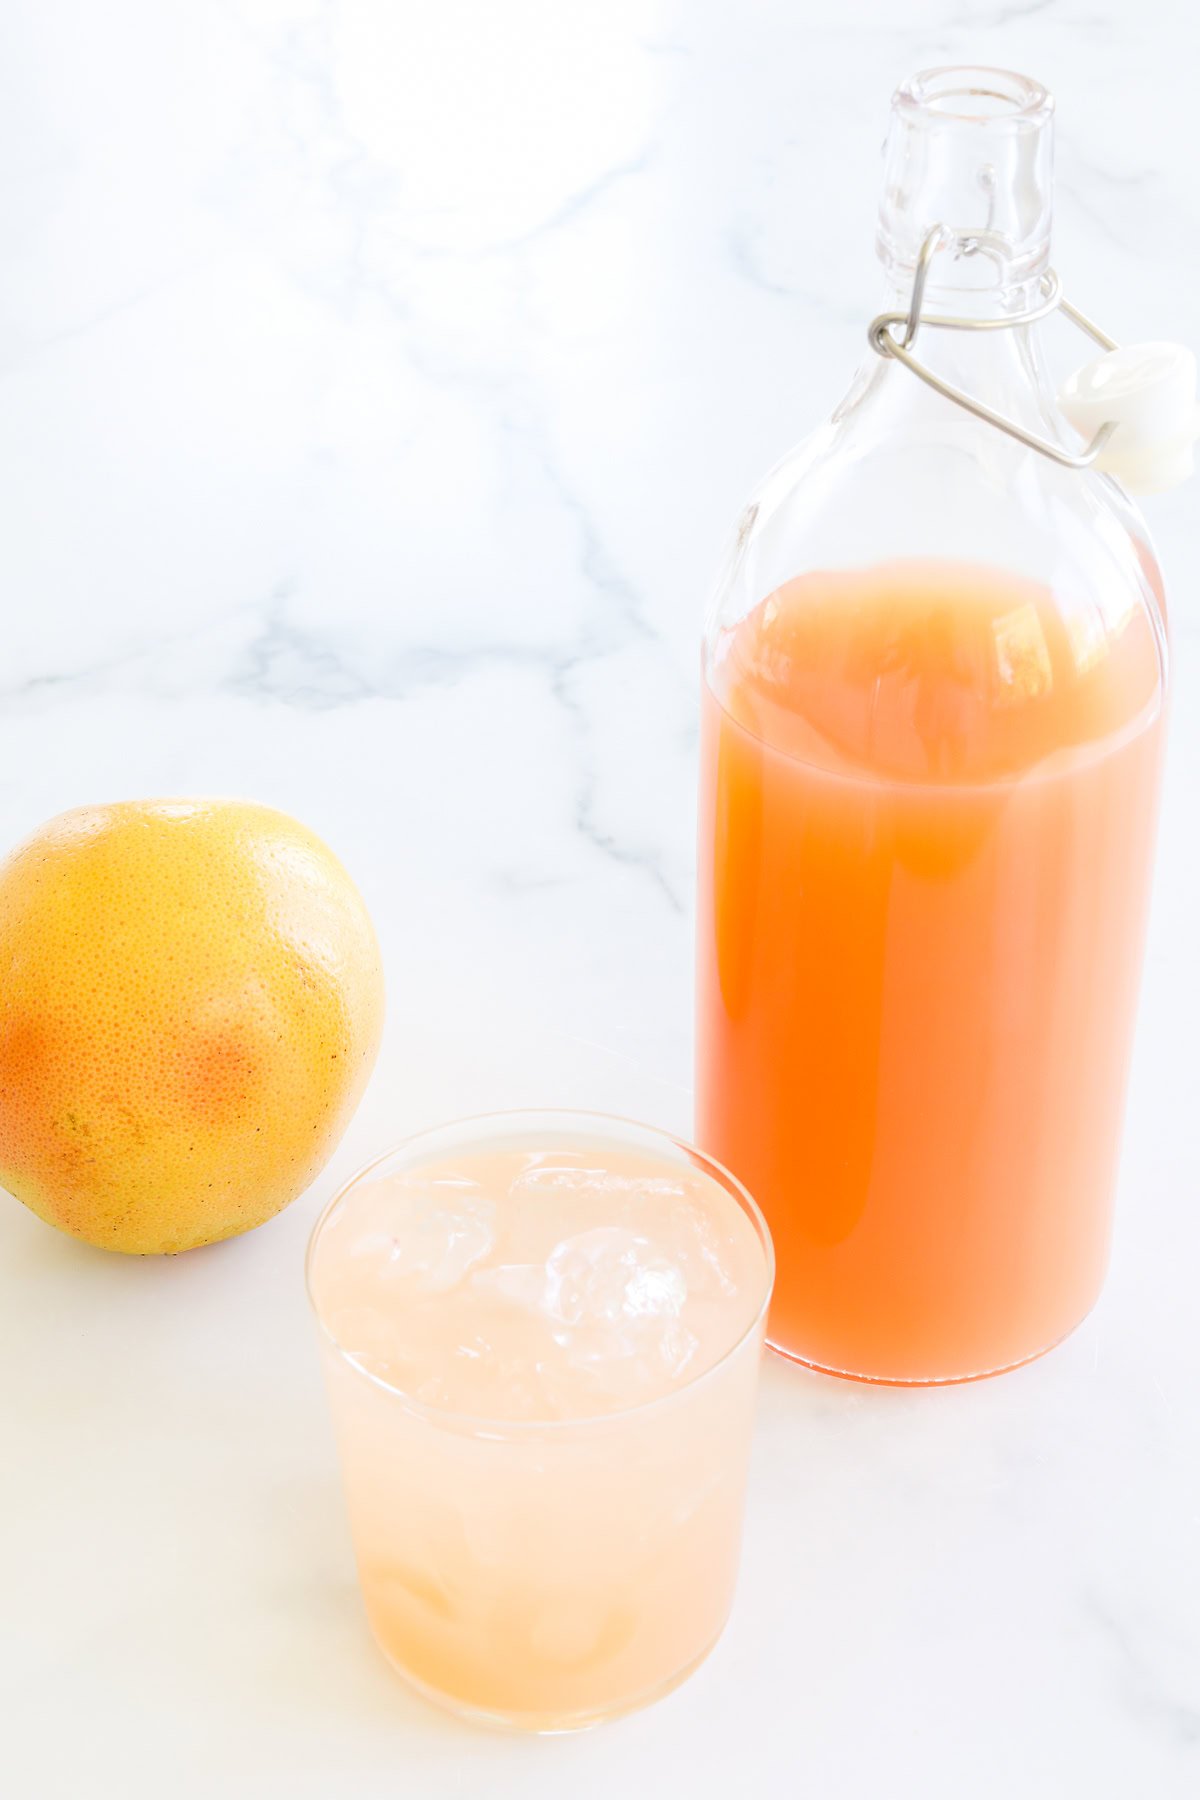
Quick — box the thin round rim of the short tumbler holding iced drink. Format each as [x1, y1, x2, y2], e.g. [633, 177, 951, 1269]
[304, 1107, 775, 1438]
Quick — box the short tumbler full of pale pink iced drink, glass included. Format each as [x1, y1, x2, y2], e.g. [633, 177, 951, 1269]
[308, 1112, 774, 1732]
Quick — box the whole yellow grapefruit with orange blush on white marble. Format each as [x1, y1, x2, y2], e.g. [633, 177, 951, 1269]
[0, 799, 383, 1256]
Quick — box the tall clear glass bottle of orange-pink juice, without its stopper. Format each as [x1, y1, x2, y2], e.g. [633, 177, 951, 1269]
[696, 68, 1168, 1382]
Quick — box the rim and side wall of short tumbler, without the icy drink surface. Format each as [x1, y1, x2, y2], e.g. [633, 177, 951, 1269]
[306, 1112, 774, 1732]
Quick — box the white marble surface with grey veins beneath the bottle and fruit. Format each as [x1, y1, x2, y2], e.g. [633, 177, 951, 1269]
[0, 0, 1200, 1800]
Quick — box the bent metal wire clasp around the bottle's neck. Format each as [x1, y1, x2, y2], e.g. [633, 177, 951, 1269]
[867, 225, 1117, 468]
